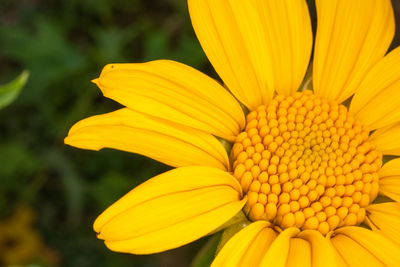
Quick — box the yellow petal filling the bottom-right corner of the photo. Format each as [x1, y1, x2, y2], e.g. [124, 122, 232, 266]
[331, 226, 400, 266]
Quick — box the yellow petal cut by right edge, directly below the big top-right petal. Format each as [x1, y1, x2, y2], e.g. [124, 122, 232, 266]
[350, 47, 400, 130]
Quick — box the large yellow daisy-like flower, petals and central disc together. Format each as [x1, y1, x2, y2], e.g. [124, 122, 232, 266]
[65, 0, 400, 266]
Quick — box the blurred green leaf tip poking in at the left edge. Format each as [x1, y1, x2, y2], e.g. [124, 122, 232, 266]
[0, 70, 29, 109]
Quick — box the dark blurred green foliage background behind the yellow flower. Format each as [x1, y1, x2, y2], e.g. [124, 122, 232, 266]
[0, 0, 400, 267]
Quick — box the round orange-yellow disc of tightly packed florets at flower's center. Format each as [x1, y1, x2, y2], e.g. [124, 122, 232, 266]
[231, 90, 382, 235]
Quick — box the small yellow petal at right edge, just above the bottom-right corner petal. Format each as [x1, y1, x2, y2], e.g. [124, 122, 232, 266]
[366, 202, 400, 245]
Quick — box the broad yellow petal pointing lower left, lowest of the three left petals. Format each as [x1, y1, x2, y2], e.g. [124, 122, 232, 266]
[94, 166, 246, 254]
